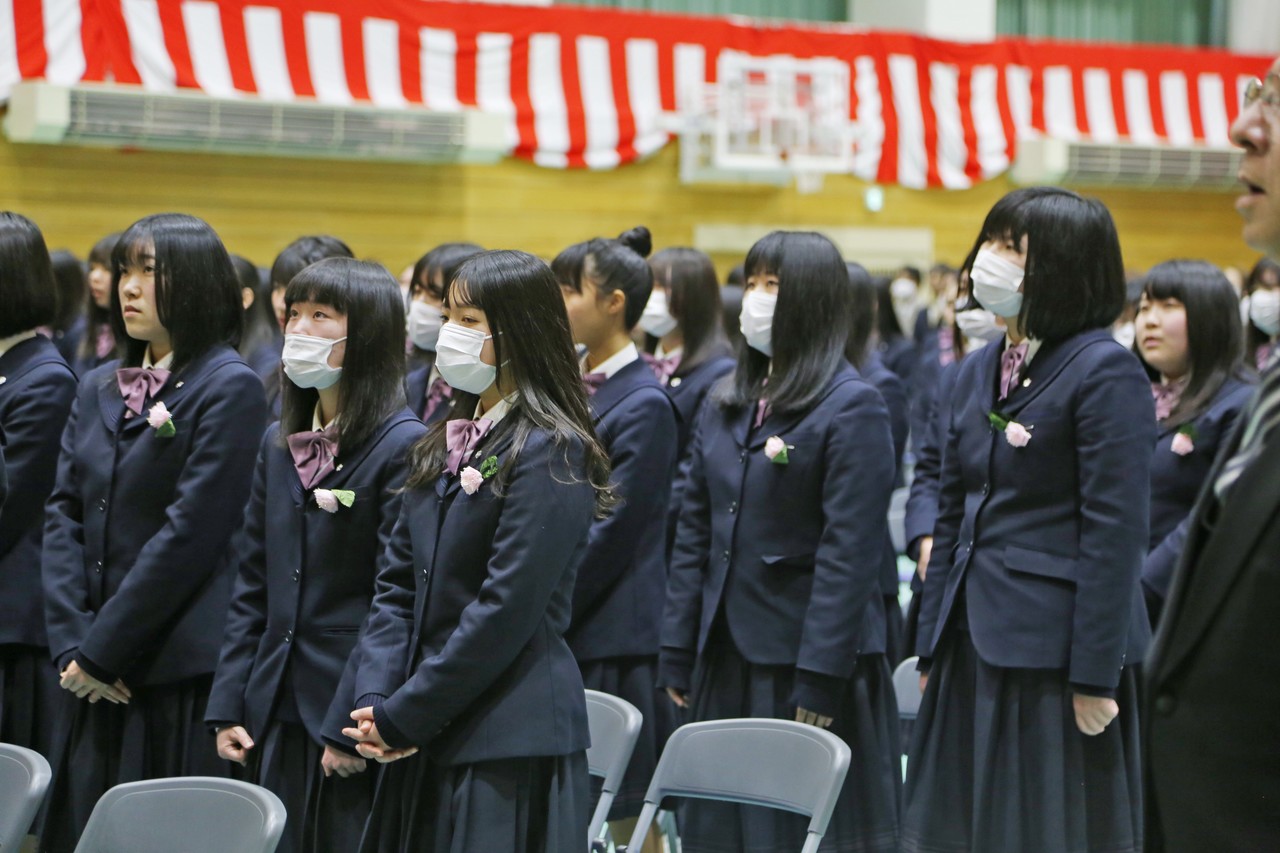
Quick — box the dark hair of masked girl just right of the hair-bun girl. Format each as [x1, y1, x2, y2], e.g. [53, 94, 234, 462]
[648, 246, 728, 375]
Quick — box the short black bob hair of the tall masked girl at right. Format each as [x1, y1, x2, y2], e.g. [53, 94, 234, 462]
[974, 187, 1125, 341]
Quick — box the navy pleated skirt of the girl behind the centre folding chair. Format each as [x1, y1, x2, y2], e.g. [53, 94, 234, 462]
[678, 631, 902, 853]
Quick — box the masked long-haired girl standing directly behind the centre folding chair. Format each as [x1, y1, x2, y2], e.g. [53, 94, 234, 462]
[659, 232, 901, 852]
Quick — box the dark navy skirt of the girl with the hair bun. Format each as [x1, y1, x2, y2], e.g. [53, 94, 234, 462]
[581, 657, 678, 821]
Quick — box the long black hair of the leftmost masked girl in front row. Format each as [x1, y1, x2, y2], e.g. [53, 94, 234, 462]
[280, 257, 404, 450]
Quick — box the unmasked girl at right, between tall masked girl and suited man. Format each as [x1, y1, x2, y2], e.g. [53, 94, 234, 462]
[1134, 260, 1254, 629]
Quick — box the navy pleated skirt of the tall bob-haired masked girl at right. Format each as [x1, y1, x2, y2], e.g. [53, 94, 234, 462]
[902, 628, 1142, 853]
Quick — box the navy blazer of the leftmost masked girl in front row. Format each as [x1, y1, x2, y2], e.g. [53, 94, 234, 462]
[205, 409, 426, 743]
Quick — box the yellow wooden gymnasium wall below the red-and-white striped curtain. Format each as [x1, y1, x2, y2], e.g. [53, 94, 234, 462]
[0, 124, 1256, 273]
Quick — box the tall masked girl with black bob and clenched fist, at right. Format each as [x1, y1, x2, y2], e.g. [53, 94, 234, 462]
[902, 187, 1155, 853]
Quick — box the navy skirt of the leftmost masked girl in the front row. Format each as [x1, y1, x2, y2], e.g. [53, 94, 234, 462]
[247, 721, 380, 853]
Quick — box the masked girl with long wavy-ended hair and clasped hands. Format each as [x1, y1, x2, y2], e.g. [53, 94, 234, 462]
[332, 251, 613, 853]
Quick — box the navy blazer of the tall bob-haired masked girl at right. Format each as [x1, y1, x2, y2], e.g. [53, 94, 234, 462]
[916, 329, 1156, 692]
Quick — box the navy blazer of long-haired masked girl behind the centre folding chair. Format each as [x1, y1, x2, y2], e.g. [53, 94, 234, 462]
[662, 364, 893, 713]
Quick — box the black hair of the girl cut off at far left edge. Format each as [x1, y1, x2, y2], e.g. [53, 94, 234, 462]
[0, 210, 58, 338]
